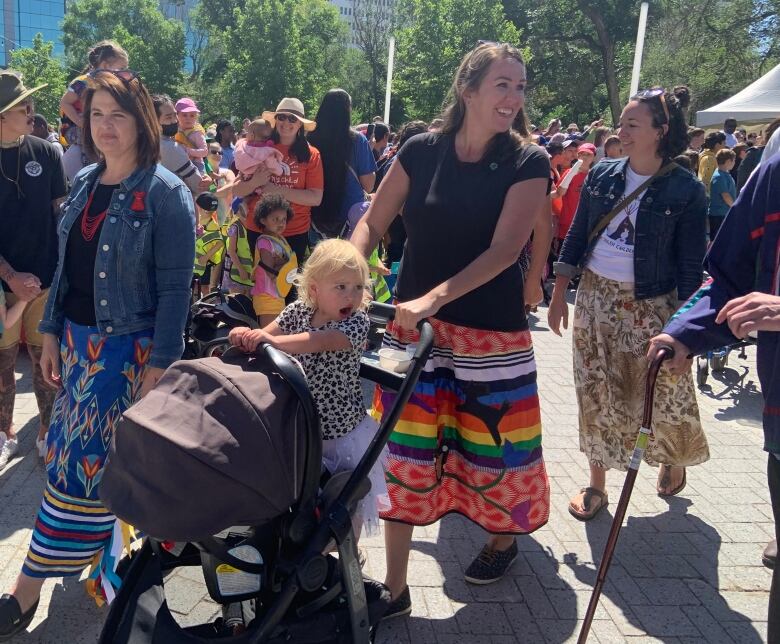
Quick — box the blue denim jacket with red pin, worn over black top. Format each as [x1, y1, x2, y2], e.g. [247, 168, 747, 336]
[39, 164, 195, 368]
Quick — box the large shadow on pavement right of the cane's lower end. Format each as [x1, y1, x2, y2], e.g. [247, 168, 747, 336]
[564, 497, 768, 644]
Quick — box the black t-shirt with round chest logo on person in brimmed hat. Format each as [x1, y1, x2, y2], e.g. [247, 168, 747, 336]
[0, 136, 68, 291]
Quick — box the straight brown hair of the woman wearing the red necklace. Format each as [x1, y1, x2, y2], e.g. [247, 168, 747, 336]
[83, 72, 160, 168]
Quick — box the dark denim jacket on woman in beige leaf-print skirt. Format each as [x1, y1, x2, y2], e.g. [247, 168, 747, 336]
[554, 159, 707, 300]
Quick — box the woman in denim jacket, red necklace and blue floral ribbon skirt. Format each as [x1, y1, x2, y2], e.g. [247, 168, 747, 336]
[0, 70, 195, 640]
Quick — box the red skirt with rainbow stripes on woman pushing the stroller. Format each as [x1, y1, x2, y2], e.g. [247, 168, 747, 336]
[373, 320, 550, 534]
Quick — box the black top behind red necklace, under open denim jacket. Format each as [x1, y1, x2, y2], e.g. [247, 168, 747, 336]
[62, 183, 119, 326]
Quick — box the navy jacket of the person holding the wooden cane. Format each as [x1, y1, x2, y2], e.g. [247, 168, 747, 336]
[664, 154, 780, 454]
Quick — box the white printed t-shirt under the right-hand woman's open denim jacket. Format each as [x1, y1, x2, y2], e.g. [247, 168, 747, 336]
[587, 165, 650, 282]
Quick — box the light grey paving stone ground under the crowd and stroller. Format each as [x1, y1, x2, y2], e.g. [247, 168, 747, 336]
[0, 300, 774, 644]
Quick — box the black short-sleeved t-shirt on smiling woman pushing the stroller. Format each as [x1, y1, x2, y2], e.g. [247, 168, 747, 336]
[396, 133, 550, 331]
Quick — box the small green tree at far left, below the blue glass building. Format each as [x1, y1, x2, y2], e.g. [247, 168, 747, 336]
[8, 34, 68, 123]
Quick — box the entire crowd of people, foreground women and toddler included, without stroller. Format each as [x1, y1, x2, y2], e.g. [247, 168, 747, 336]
[0, 41, 780, 642]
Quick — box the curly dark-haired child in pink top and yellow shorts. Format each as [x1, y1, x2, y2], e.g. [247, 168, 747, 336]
[252, 195, 298, 327]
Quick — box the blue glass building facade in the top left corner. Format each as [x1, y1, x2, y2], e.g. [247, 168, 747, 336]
[0, 0, 66, 67]
